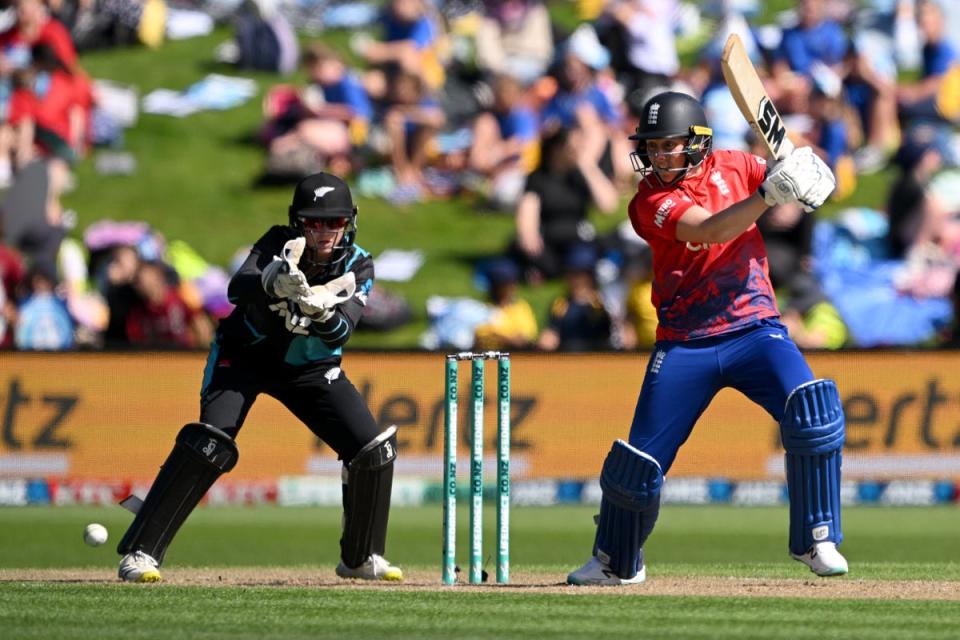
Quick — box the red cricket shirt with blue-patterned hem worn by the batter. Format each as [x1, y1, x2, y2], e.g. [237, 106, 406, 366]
[628, 151, 780, 340]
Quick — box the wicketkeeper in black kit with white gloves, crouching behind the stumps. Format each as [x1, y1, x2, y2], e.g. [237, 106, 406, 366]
[117, 173, 403, 582]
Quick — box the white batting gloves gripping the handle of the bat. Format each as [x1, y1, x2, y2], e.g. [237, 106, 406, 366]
[760, 147, 837, 213]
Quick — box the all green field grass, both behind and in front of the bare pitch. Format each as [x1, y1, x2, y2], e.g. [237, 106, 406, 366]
[0, 506, 960, 639]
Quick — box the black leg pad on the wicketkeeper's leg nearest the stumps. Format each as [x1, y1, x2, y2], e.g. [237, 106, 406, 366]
[340, 426, 397, 567]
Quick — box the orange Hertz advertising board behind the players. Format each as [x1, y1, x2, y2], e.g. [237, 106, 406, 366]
[0, 352, 960, 481]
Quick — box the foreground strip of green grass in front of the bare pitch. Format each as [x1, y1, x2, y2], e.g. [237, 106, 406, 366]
[0, 585, 960, 640]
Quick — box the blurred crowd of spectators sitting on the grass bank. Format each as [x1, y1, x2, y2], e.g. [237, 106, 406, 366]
[0, 0, 960, 351]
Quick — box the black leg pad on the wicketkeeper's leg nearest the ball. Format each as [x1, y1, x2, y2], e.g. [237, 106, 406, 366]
[117, 422, 239, 562]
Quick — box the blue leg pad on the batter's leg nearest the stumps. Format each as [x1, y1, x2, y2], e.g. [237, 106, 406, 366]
[593, 440, 663, 578]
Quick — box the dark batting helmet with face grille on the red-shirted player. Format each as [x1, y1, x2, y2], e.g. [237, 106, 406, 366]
[630, 91, 713, 184]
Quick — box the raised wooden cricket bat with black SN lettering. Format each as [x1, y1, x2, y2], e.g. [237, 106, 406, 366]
[720, 33, 793, 160]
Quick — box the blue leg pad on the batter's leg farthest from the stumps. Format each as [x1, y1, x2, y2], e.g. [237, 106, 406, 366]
[780, 380, 844, 555]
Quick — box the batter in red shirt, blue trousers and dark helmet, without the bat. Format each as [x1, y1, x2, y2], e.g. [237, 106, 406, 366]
[567, 92, 847, 585]
